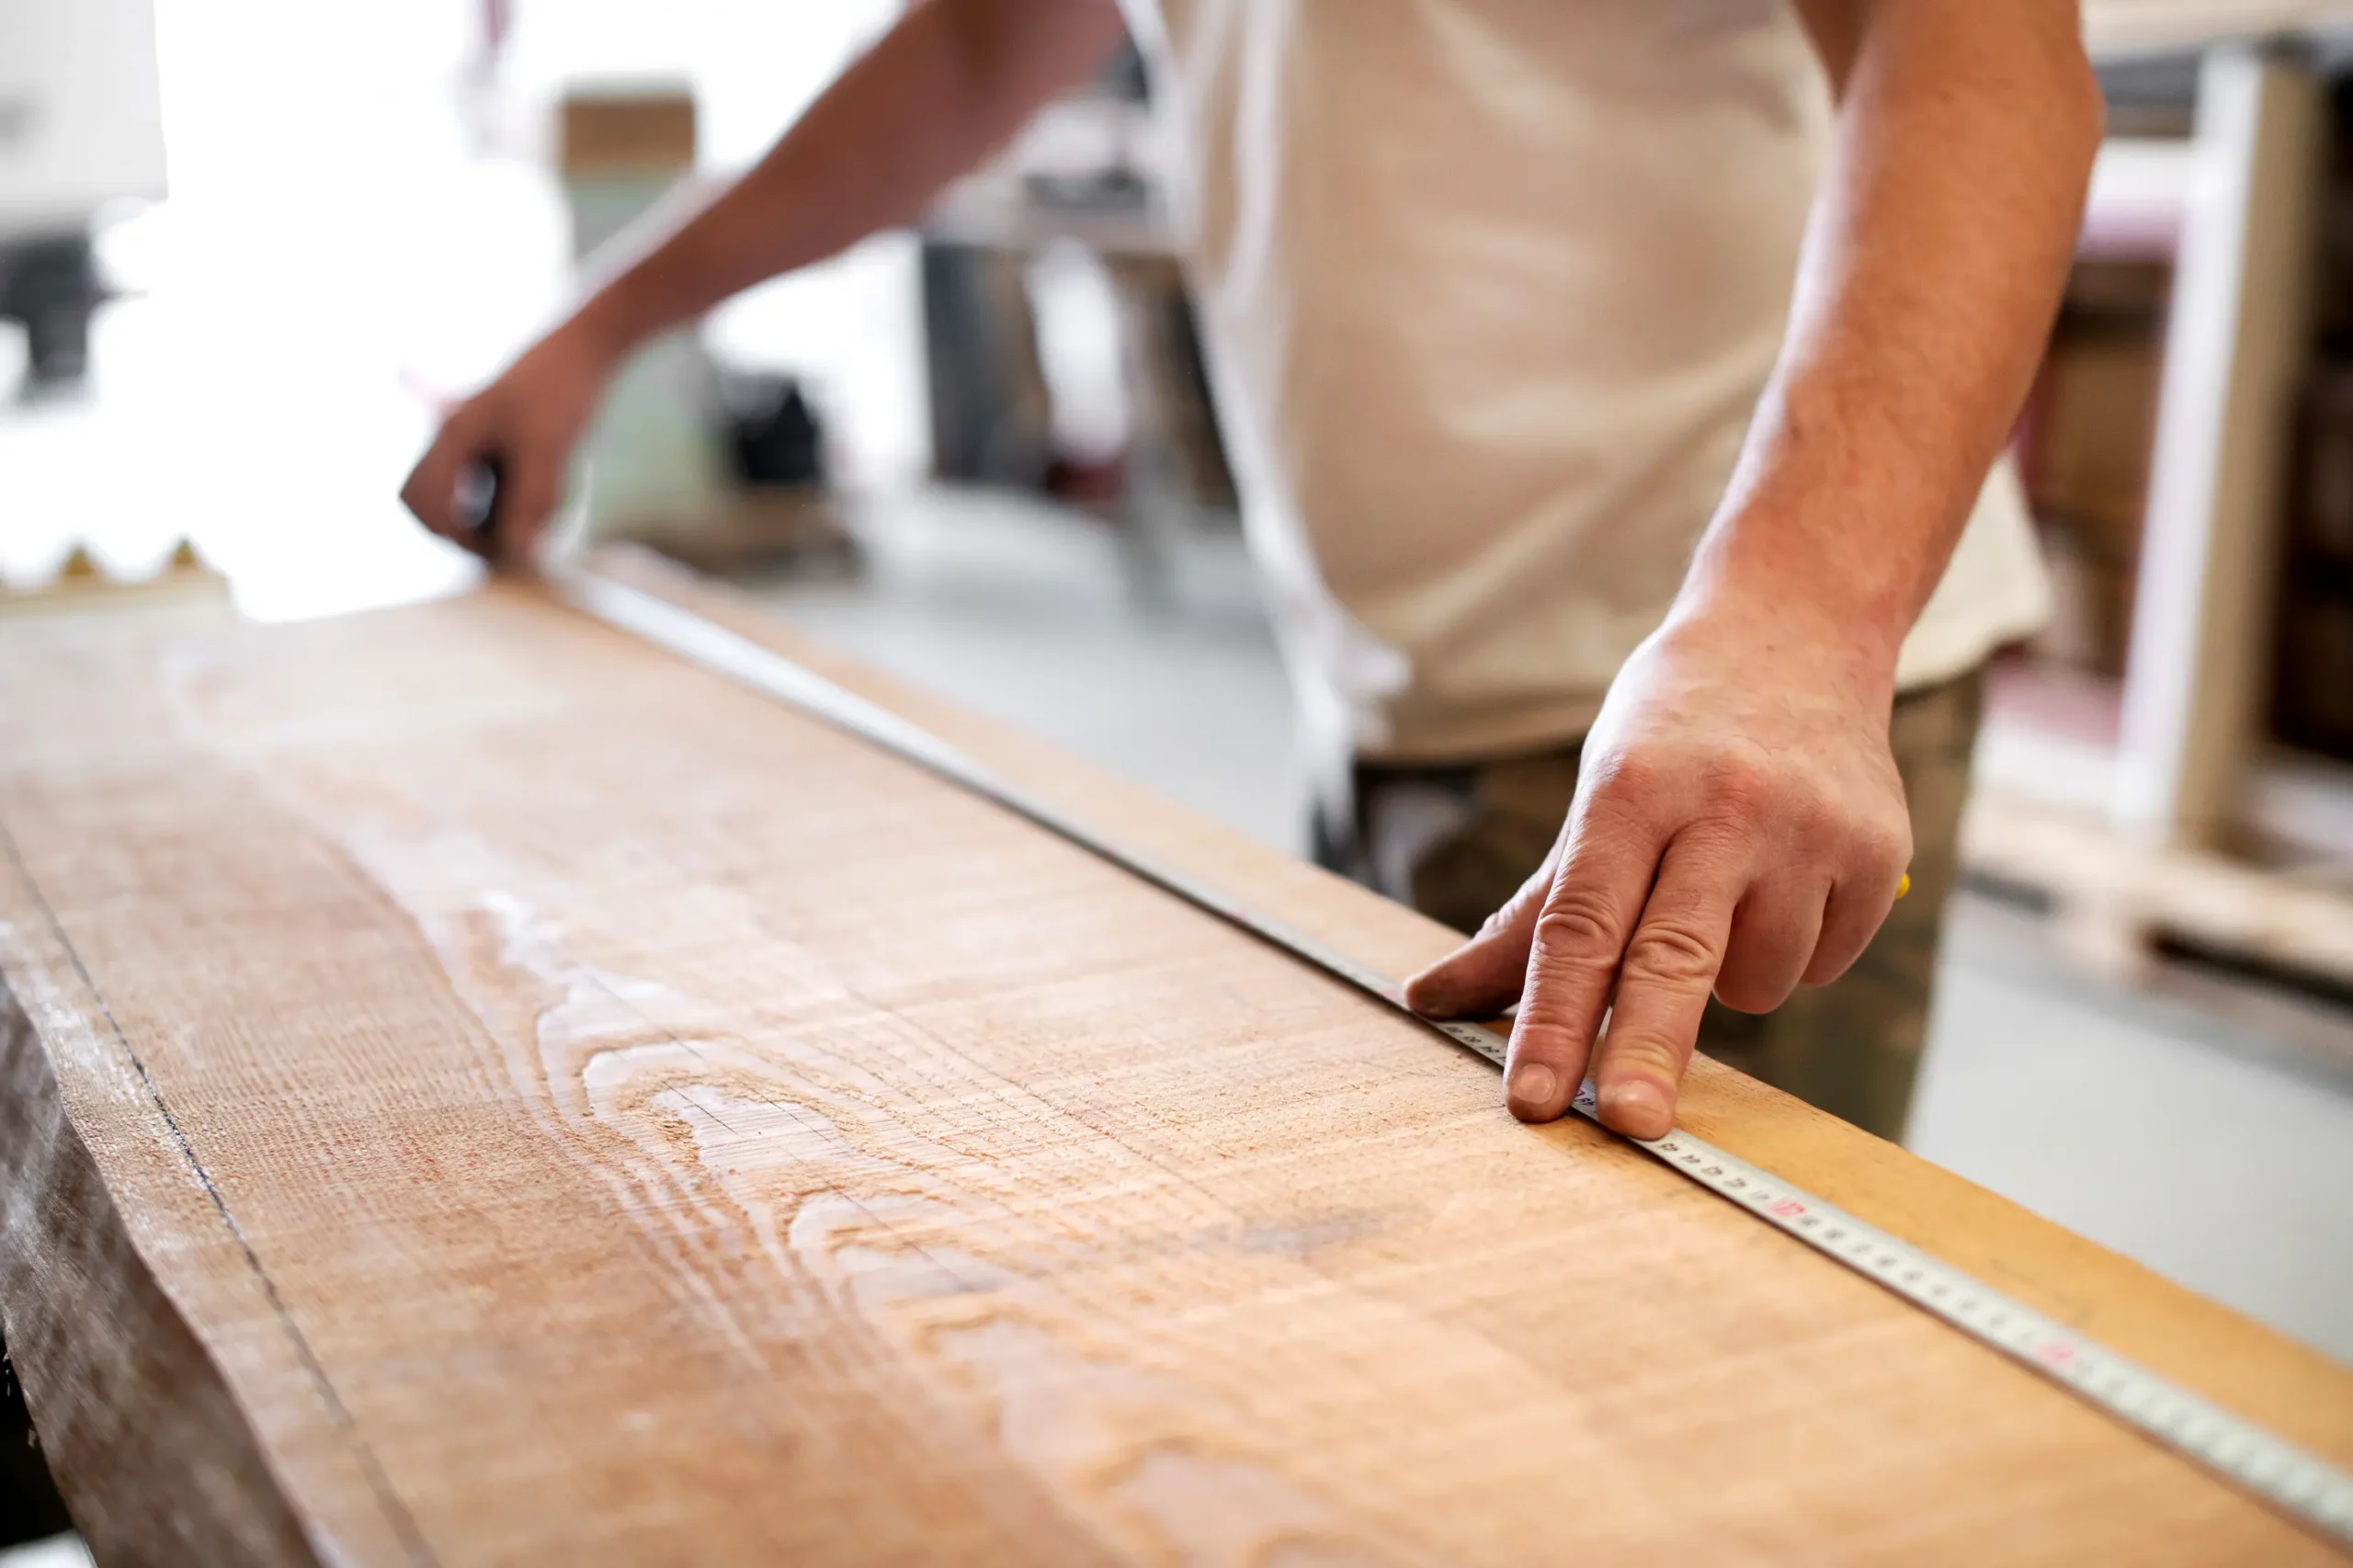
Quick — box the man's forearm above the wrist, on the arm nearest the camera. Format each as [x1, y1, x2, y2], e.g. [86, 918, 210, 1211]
[1685, 0, 2101, 680]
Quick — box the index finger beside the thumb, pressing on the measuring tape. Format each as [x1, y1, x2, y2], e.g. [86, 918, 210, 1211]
[1504, 798, 1661, 1120]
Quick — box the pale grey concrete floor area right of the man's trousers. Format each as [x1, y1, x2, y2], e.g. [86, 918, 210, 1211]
[1908, 900, 2353, 1361]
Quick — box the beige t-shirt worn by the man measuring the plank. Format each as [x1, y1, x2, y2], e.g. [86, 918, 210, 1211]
[1136, 0, 2047, 760]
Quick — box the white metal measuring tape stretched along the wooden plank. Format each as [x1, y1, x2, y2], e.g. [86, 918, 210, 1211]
[548, 570, 2353, 1547]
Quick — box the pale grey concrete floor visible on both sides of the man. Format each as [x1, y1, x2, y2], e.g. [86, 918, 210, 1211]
[760, 483, 2353, 1361]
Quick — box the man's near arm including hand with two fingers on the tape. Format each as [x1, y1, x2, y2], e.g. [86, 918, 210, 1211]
[1407, 0, 2101, 1137]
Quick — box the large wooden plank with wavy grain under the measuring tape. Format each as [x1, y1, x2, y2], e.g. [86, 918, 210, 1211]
[0, 564, 2353, 1563]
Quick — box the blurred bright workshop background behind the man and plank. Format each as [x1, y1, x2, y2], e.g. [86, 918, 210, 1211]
[0, 0, 2353, 1544]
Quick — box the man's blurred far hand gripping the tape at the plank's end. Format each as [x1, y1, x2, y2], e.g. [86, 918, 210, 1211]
[400, 318, 617, 562]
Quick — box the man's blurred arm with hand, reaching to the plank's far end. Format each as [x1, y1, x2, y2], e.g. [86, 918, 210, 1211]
[400, 0, 1122, 558]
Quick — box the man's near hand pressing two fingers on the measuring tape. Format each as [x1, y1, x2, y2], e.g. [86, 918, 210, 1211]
[1404, 603, 1911, 1137]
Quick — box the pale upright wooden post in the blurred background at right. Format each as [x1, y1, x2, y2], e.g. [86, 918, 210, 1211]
[2115, 47, 2327, 847]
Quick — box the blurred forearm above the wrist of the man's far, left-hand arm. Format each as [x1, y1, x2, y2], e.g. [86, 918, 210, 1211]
[572, 0, 1120, 353]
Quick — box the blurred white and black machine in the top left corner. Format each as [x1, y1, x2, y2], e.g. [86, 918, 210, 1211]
[0, 0, 165, 391]
